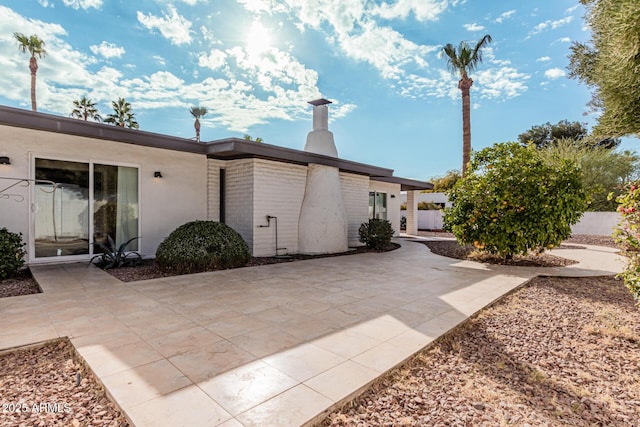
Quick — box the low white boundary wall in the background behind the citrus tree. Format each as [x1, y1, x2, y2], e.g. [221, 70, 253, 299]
[400, 210, 620, 236]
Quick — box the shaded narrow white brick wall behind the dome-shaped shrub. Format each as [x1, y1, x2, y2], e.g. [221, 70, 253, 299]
[225, 159, 257, 249]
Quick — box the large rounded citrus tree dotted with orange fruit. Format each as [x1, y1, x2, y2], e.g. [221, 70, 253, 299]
[444, 142, 587, 258]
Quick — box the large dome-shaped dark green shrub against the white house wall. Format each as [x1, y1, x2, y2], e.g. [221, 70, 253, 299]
[156, 221, 251, 274]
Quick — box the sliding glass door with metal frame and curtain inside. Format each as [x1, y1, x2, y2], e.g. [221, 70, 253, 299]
[31, 158, 139, 258]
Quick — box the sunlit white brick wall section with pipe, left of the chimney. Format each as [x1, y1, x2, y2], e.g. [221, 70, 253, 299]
[253, 159, 307, 256]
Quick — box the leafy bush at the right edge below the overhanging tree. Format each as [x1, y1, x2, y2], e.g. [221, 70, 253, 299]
[613, 182, 640, 305]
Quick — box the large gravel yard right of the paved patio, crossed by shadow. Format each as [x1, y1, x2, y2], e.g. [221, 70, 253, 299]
[320, 277, 640, 427]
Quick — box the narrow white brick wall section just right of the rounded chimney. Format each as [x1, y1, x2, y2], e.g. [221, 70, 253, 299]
[340, 172, 369, 247]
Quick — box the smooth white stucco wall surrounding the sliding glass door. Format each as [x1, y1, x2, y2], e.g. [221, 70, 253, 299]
[0, 125, 207, 261]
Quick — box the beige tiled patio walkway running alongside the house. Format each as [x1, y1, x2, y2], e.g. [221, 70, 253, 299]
[0, 241, 624, 427]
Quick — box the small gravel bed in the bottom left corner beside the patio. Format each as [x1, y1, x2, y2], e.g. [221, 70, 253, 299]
[0, 339, 129, 427]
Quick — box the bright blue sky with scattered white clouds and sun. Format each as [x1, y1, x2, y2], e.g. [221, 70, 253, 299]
[0, 0, 638, 180]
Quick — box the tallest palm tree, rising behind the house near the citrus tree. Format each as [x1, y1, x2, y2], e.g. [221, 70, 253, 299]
[442, 34, 491, 176]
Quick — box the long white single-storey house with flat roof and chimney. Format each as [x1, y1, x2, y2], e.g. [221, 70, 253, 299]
[0, 102, 431, 264]
